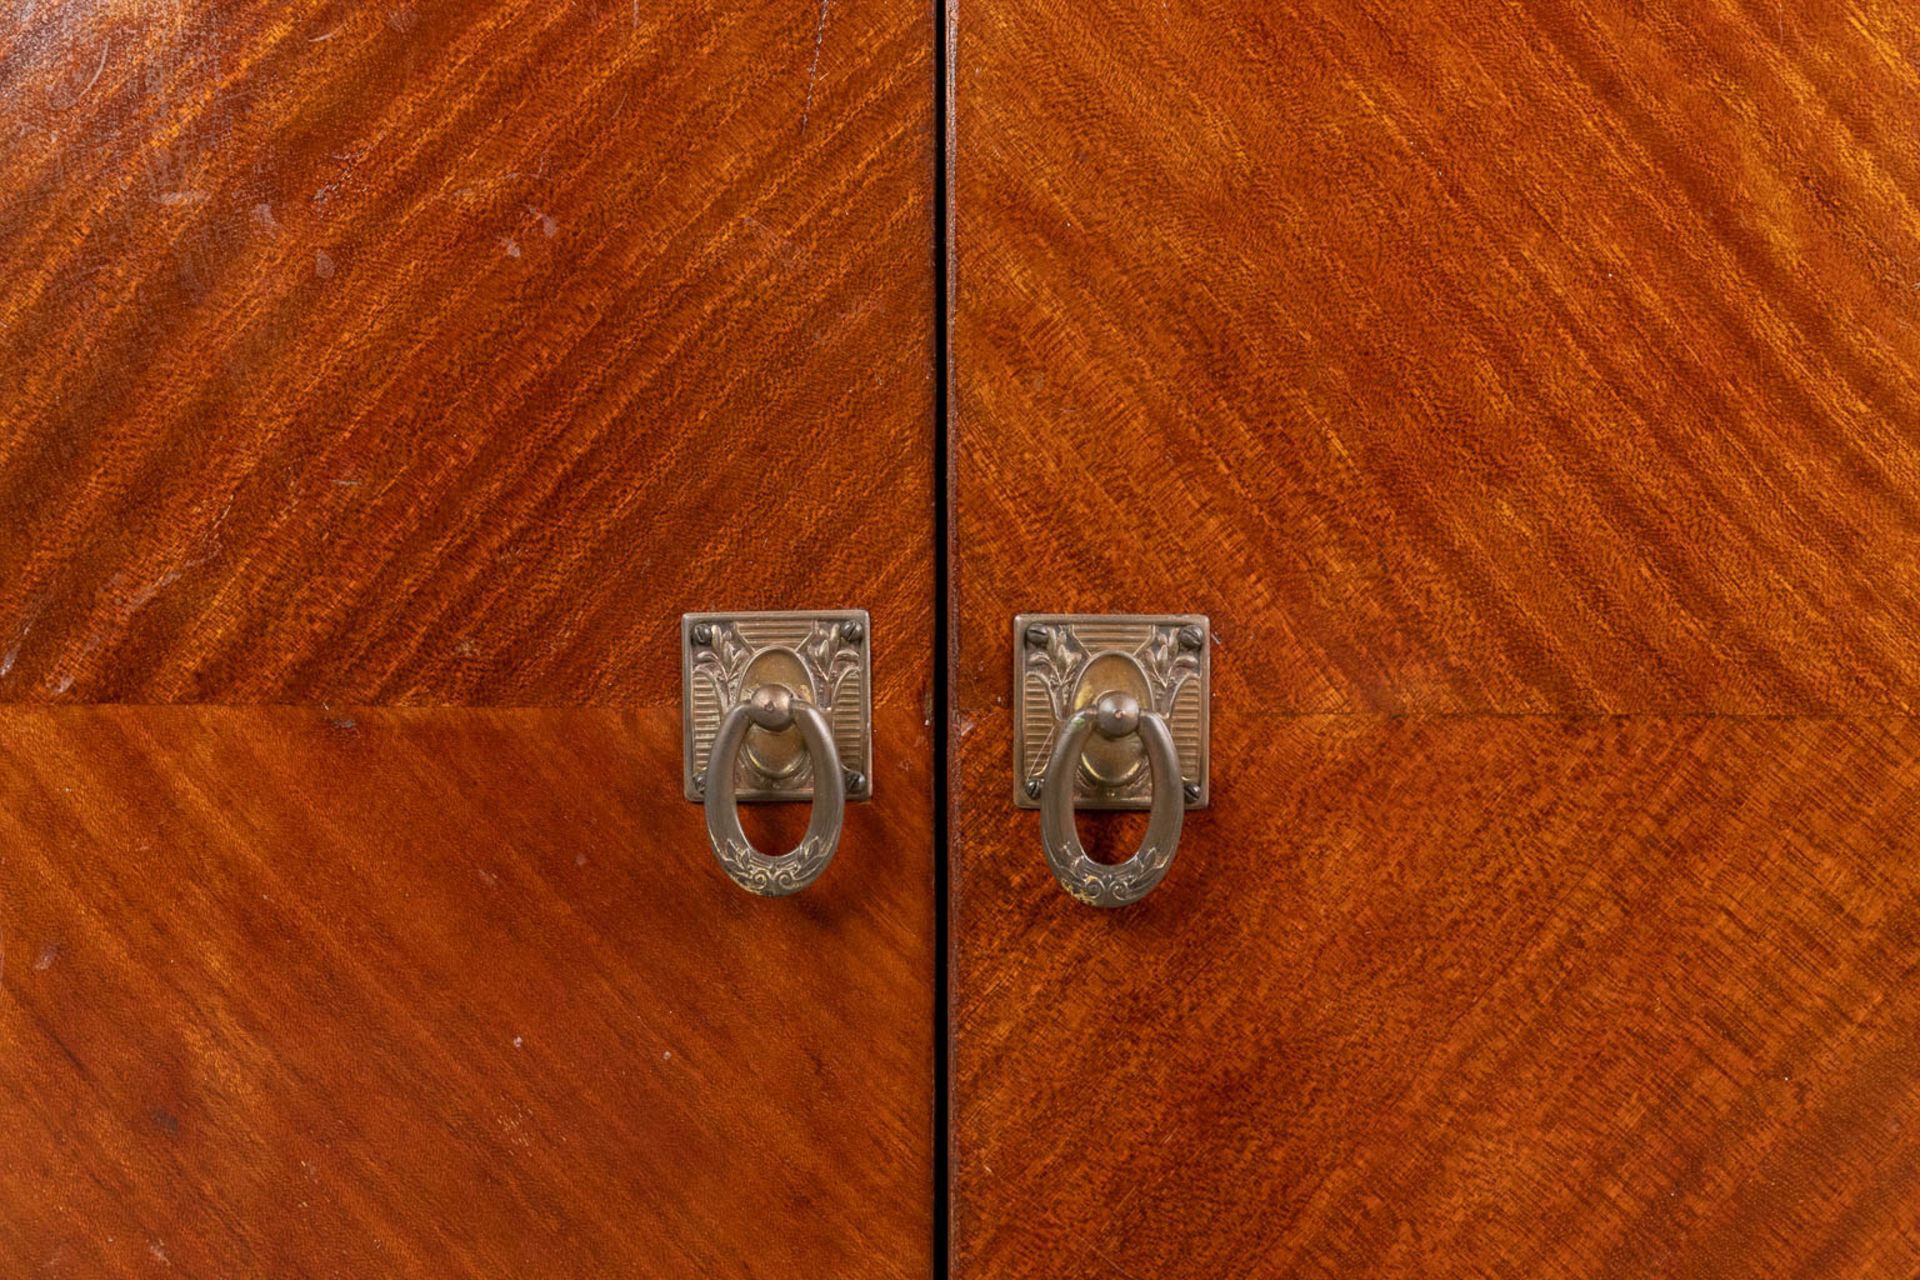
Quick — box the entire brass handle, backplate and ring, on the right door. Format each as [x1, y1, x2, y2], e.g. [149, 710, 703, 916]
[1014, 614, 1210, 908]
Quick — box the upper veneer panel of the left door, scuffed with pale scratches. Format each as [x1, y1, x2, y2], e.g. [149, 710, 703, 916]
[0, 0, 933, 704]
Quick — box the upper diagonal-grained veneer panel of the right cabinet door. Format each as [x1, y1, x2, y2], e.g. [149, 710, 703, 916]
[952, 0, 1920, 712]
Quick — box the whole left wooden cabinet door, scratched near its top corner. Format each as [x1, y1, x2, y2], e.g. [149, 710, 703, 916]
[0, 0, 937, 1278]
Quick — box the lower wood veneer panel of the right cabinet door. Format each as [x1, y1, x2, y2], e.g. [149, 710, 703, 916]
[954, 710, 1920, 1280]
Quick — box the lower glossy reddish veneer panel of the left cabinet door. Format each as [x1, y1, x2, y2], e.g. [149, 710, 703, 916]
[0, 708, 933, 1280]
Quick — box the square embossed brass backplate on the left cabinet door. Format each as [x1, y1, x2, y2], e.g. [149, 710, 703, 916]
[680, 608, 874, 802]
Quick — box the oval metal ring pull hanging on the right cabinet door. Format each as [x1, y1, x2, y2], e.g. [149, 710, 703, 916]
[1041, 695, 1187, 908]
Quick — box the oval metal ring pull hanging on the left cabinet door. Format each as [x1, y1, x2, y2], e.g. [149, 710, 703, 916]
[707, 685, 847, 898]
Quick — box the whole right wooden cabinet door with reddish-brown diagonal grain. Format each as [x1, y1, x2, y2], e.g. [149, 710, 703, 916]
[952, 0, 1920, 1280]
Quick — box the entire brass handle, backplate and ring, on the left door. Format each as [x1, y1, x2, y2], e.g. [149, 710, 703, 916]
[680, 608, 874, 898]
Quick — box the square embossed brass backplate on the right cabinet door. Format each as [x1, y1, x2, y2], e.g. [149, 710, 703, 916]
[1014, 614, 1213, 810]
